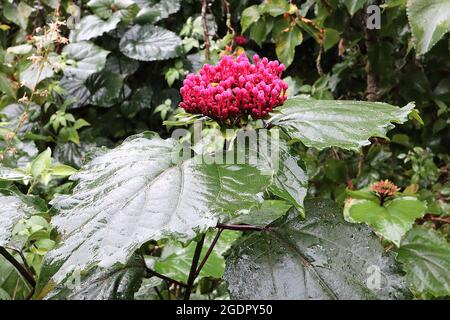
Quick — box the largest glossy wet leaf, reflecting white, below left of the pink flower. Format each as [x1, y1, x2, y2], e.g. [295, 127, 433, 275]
[40, 133, 270, 283]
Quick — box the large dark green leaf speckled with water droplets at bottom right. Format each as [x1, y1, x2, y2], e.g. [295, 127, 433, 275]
[224, 200, 404, 299]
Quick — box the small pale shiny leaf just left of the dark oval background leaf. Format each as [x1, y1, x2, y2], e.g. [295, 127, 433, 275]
[70, 15, 120, 42]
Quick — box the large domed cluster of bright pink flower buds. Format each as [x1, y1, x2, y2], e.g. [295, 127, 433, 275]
[180, 54, 288, 121]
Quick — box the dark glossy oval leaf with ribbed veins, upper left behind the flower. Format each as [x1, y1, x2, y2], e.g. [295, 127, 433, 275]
[119, 25, 181, 61]
